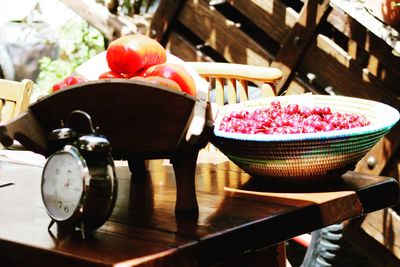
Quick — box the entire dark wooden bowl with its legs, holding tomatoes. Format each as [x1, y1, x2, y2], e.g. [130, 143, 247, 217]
[0, 79, 212, 216]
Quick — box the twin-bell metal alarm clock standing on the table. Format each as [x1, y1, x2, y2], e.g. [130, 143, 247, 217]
[41, 111, 117, 238]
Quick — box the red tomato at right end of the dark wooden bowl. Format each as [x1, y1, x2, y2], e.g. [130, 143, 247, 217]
[142, 63, 196, 96]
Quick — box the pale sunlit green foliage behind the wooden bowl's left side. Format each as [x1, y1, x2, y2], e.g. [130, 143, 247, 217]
[36, 18, 105, 94]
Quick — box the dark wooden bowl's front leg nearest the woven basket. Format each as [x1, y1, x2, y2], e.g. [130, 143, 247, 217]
[171, 150, 199, 214]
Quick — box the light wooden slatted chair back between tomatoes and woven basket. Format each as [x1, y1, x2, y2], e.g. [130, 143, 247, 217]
[184, 62, 282, 106]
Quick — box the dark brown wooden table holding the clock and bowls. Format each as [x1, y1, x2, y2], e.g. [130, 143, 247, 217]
[0, 153, 399, 266]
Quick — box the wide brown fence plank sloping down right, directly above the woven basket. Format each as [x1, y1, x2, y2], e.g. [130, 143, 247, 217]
[296, 34, 400, 108]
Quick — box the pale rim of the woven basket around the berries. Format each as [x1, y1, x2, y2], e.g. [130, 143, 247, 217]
[214, 94, 400, 142]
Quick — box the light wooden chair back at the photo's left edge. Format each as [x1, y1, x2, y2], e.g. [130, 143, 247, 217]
[0, 79, 33, 123]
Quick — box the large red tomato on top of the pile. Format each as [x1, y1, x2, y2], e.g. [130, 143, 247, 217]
[106, 34, 167, 76]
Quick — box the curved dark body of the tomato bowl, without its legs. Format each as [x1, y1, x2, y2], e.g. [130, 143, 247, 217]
[1, 79, 196, 158]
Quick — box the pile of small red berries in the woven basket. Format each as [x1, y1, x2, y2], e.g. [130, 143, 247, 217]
[219, 101, 370, 134]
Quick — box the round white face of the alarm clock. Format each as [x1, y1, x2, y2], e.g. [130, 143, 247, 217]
[41, 151, 87, 221]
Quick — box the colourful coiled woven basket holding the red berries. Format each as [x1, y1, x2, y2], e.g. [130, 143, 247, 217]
[212, 94, 399, 182]
